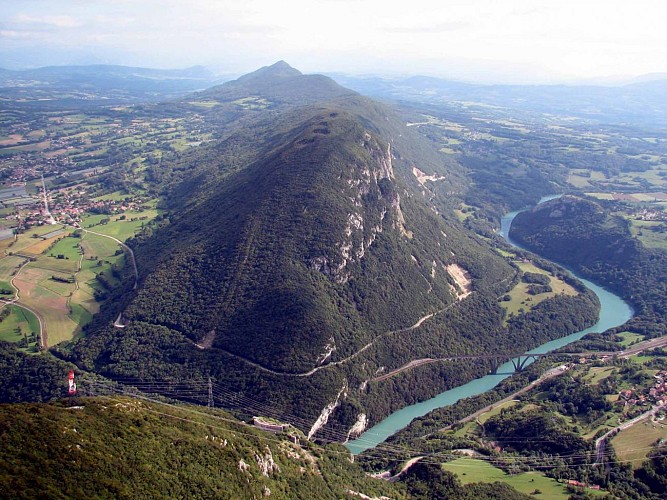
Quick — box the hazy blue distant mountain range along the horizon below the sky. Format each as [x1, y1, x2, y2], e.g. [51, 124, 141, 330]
[5, 62, 667, 127]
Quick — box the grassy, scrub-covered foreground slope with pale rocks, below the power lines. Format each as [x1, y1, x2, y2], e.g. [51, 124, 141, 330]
[0, 397, 404, 499]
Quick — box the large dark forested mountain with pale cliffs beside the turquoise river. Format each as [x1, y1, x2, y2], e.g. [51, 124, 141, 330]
[62, 62, 597, 440]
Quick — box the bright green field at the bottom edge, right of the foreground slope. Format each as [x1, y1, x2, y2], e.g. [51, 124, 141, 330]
[443, 458, 604, 499]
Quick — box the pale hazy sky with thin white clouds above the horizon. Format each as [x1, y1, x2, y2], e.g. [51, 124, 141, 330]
[0, 0, 667, 81]
